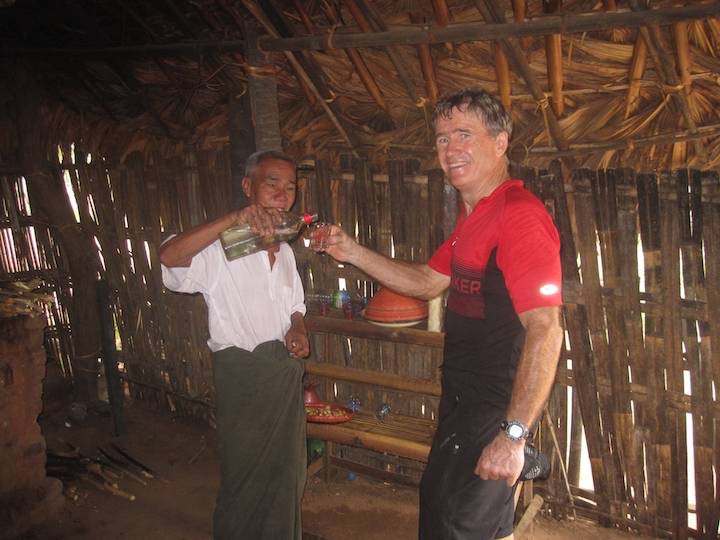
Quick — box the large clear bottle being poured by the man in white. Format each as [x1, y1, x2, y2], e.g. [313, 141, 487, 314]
[220, 211, 318, 261]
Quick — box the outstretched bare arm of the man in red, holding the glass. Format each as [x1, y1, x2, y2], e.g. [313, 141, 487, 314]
[325, 225, 450, 300]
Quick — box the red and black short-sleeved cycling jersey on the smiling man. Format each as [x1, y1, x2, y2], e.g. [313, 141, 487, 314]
[428, 180, 562, 407]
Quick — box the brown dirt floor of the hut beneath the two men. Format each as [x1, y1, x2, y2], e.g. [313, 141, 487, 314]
[22, 406, 648, 540]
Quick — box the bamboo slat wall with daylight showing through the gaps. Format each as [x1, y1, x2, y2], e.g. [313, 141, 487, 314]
[2, 149, 720, 538]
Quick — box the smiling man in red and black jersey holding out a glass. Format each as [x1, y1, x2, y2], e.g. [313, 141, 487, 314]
[325, 89, 563, 540]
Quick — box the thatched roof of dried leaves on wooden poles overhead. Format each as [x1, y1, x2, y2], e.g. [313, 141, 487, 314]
[0, 0, 720, 169]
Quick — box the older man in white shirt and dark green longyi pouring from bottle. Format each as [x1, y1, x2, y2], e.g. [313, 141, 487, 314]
[160, 151, 310, 540]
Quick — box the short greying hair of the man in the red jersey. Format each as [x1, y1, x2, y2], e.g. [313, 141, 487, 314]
[432, 88, 512, 138]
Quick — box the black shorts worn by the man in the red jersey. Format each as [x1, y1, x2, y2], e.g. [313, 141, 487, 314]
[420, 398, 515, 540]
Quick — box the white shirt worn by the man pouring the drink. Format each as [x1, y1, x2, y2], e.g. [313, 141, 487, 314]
[162, 240, 305, 352]
